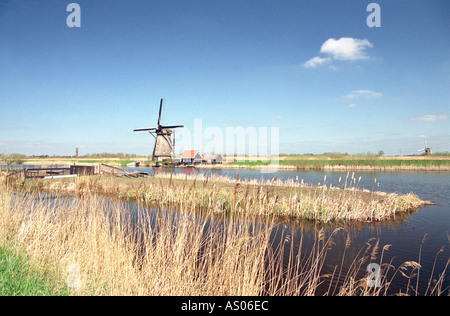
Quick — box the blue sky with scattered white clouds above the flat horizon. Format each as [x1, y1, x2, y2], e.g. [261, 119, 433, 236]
[0, 0, 450, 155]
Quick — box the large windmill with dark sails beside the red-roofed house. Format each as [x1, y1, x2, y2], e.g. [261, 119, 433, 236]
[133, 99, 184, 161]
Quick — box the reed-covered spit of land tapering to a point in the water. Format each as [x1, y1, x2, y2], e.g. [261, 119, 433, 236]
[21, 174, 431, 223]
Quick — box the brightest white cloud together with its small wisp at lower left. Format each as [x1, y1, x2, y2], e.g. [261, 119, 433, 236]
[303, 37, 373, 68]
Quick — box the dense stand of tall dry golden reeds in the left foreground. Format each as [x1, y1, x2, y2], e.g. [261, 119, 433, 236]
[0, 184, 324, 296]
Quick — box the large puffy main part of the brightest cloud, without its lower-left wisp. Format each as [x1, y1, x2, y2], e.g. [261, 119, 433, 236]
[320, 37, 373, 60]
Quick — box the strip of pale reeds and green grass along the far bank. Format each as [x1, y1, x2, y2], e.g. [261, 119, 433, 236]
[13, 153, 450, 171]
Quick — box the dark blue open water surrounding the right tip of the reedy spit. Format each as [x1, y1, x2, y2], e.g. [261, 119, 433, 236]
[129, 168, 450, 295]
